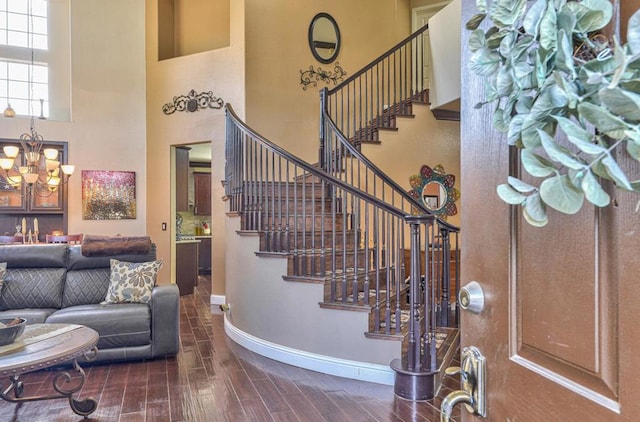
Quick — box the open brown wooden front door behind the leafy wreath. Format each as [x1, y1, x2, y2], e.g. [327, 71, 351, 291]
[460, 0, 640, 422]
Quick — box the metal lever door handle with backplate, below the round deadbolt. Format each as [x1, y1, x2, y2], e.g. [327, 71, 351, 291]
[440, 346, 487, 422]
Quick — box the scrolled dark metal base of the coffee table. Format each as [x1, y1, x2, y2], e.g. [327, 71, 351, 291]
[0, 359, 98, 418]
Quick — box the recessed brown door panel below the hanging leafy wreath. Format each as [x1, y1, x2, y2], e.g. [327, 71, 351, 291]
[509, 207, 618, 402]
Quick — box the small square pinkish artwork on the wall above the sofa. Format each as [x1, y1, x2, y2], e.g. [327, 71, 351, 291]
[82, 170, 136, 220]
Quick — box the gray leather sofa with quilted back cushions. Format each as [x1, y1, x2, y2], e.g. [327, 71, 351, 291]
[0, 244, 180, 362]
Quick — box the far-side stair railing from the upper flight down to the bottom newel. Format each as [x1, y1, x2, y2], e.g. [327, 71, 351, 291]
[319, 22, 460, 399]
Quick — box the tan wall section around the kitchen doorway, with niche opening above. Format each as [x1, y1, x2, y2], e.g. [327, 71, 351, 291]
[146, 0, 244, 294]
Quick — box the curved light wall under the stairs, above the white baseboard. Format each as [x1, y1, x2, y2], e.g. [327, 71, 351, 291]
[227, 213, 401, 365]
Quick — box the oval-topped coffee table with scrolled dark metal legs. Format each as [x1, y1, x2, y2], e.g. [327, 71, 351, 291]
[0, 324, 98, 417]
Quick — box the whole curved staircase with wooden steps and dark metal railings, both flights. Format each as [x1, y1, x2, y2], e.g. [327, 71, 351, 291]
[225, 22, 459, 400]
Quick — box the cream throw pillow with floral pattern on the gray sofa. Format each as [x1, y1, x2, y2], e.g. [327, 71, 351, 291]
[102, 259, 162, 304]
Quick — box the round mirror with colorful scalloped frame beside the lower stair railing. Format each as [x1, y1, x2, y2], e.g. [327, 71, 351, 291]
[409, 164, 460, 220]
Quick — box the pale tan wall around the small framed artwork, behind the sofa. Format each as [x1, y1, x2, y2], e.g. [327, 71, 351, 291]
[0, 0, 147, 235]
